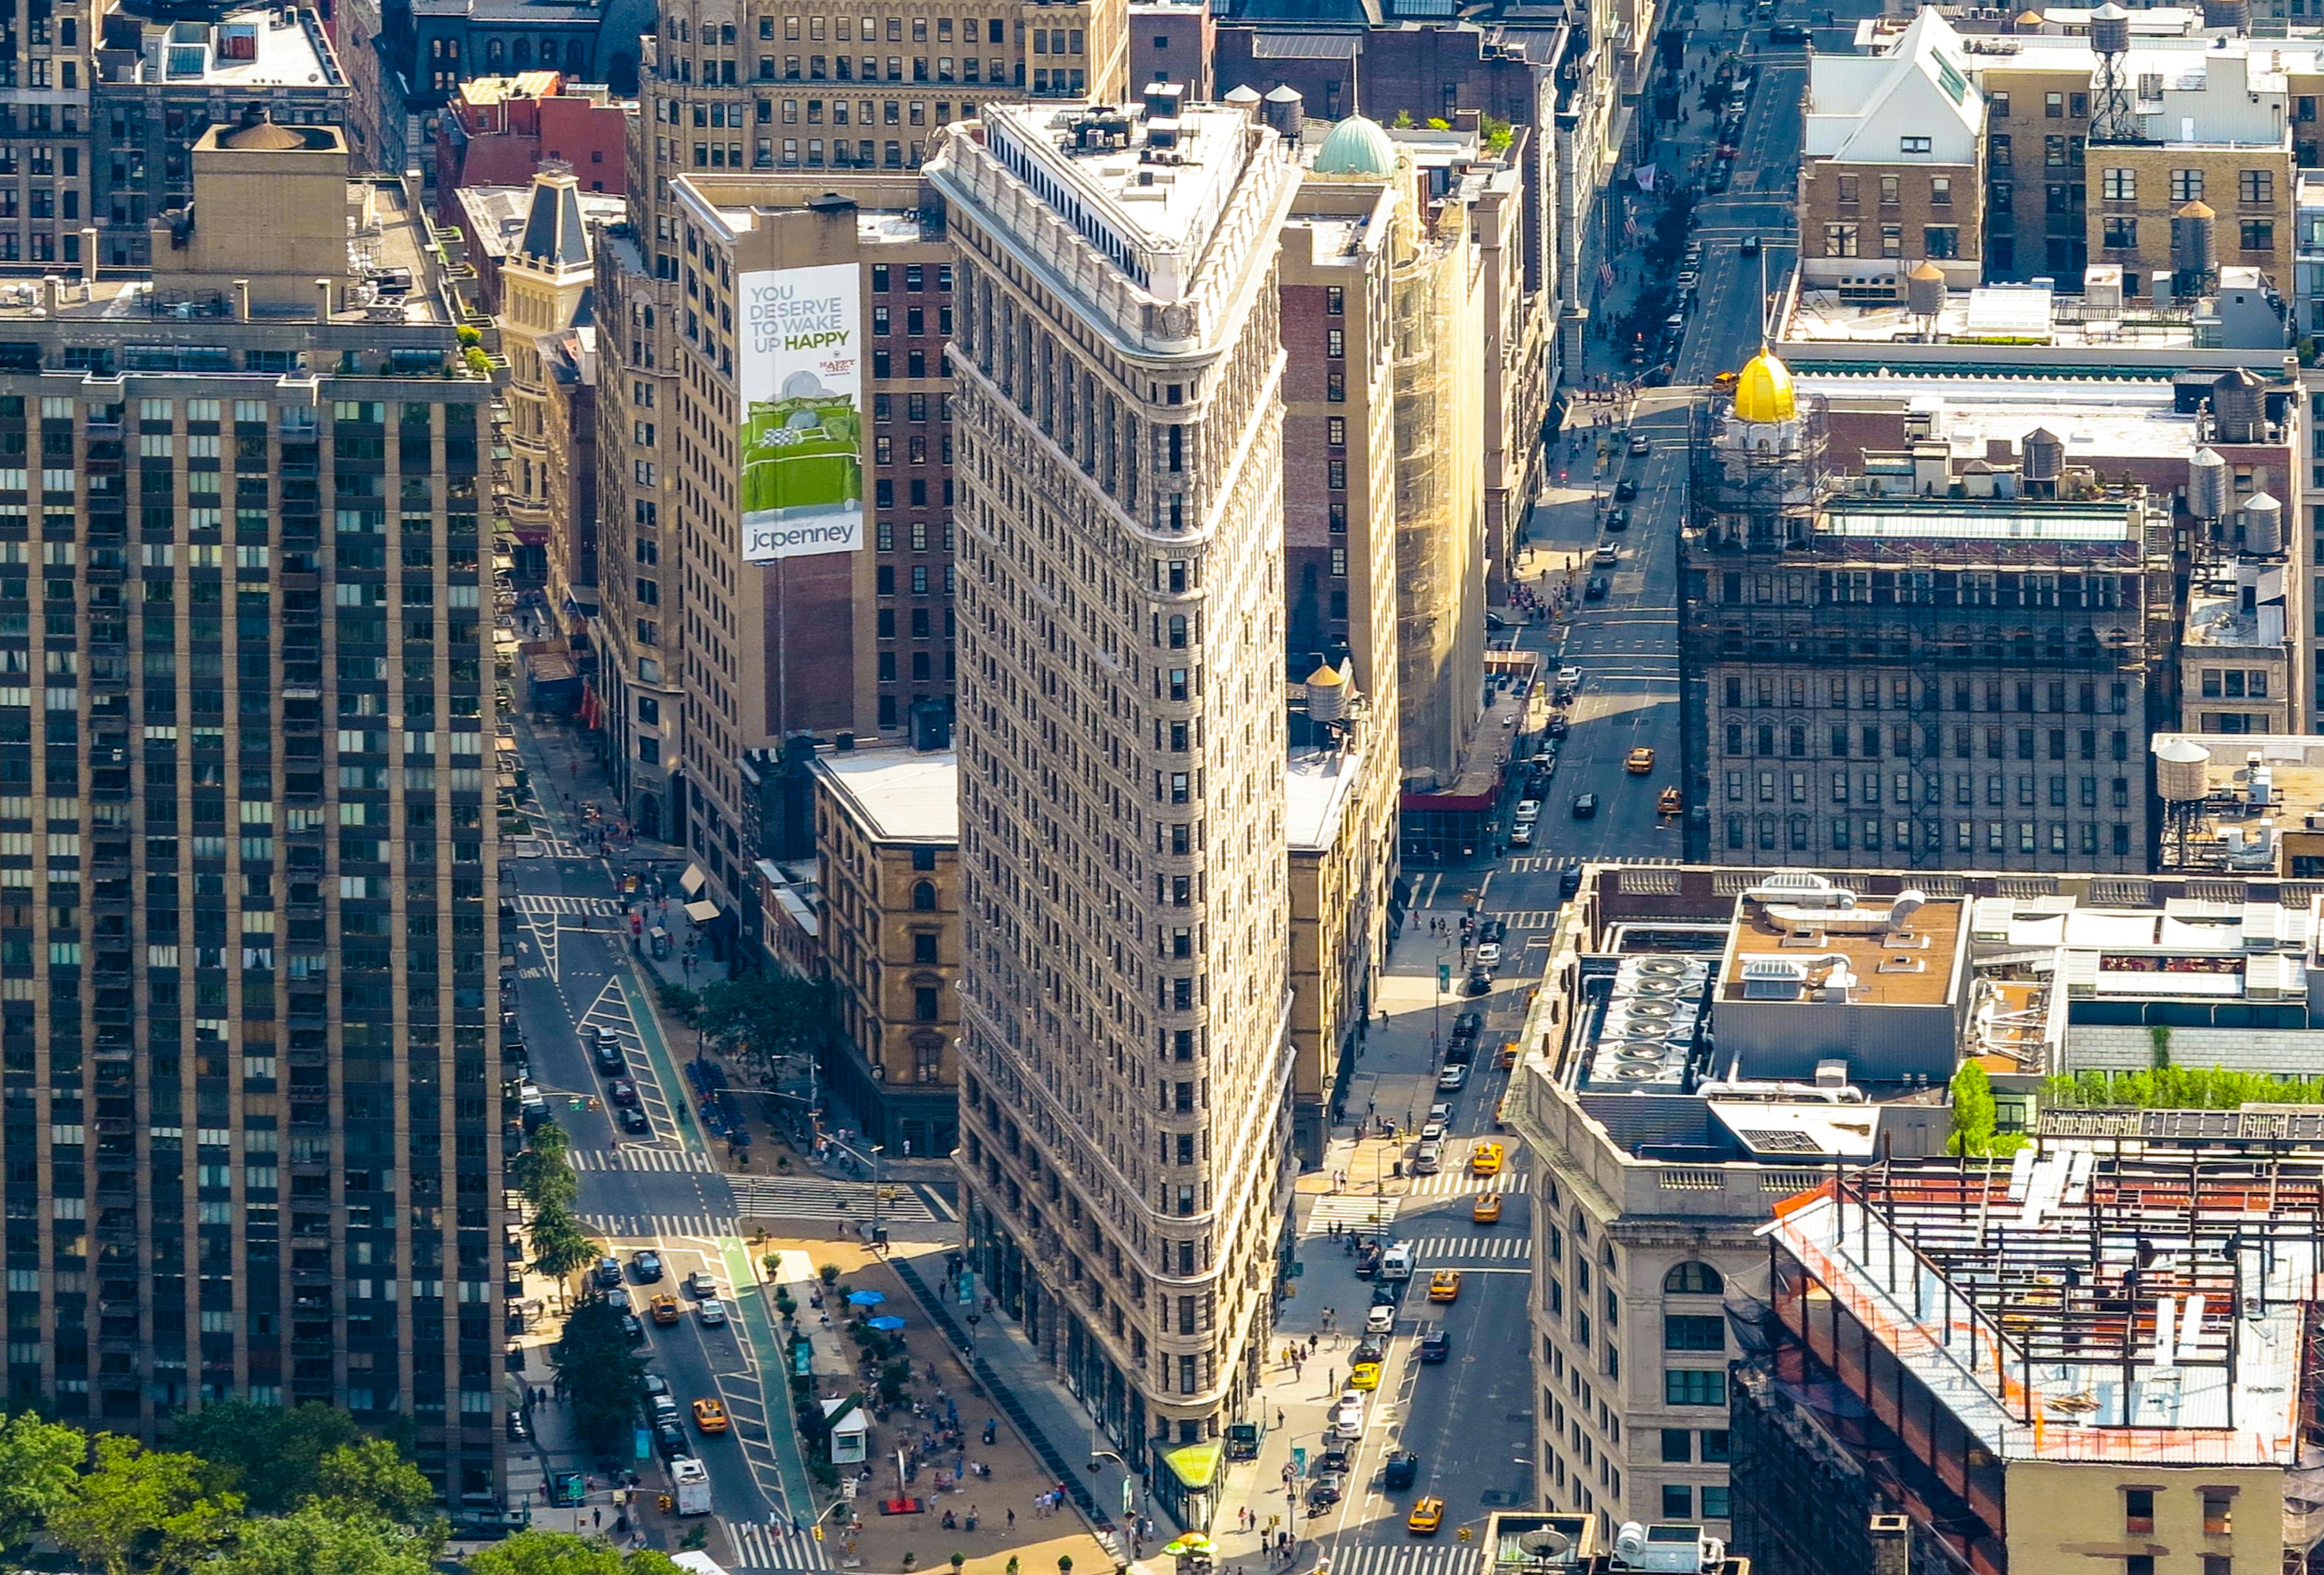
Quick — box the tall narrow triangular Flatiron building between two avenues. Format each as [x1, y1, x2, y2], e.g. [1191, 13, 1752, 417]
[929, 86, 1299, 1522]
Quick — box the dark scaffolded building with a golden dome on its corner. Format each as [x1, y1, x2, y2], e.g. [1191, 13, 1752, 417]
[1680, 353, 2178, 874]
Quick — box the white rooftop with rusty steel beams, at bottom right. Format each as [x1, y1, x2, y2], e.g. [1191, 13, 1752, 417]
[1762, 1136, 2324, 1466]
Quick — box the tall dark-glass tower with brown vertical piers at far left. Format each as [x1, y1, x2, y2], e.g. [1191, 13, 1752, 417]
[0, 111, 504, 1505]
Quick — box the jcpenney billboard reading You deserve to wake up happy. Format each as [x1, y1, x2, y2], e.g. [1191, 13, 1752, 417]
[737, 262, 864, 562]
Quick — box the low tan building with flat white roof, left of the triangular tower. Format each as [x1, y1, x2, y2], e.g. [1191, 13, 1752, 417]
[811, 746, 964, 1159]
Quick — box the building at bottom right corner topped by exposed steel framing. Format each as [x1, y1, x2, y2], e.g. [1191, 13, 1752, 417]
[1729, 1124, 2324, 1575]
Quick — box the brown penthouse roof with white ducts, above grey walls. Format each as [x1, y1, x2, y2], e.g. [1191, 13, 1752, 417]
[1717, 876, 1962, 1006]
